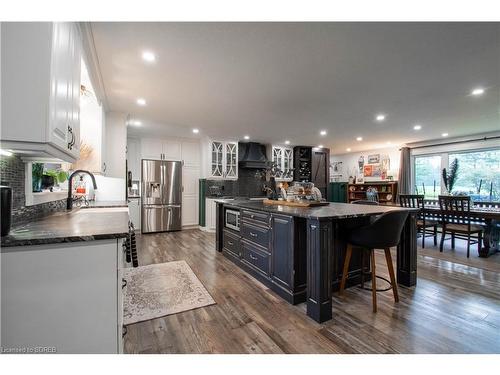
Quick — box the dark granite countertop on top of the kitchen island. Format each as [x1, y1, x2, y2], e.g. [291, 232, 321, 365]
[217, 199, 418, 219]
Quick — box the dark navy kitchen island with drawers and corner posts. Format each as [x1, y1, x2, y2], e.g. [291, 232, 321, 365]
[216, 200, 417, 322]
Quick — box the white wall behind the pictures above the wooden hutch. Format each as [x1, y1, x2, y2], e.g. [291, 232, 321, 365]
[330, 147, 400, 182]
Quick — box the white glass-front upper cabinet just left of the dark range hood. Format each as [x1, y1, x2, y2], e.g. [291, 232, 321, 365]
[210, 141, 238, 180]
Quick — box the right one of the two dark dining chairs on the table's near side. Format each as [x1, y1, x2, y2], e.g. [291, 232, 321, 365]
[438, 195, 483, 258]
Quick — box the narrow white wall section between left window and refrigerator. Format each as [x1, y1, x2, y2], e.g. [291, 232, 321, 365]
[104, 112, 127, 179]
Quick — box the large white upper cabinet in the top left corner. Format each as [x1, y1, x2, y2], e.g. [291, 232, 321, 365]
[1, 22, 81, 162]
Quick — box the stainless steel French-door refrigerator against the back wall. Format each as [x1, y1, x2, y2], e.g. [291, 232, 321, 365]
[141, 159, 182, 233]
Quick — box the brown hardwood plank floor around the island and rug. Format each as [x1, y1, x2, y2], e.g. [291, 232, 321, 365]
[125, 229, 500, 353]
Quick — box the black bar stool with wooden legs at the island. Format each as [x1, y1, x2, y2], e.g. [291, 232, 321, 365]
[339, 211, 408, 312]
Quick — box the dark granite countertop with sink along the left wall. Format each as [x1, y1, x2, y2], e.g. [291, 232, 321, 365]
[1, 206, 129, 252]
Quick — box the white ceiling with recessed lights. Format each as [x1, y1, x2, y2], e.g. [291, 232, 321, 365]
[92, 22, 500, 153]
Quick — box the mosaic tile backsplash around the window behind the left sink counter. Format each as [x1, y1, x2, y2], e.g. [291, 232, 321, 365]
[0, 155, 66, 226]
